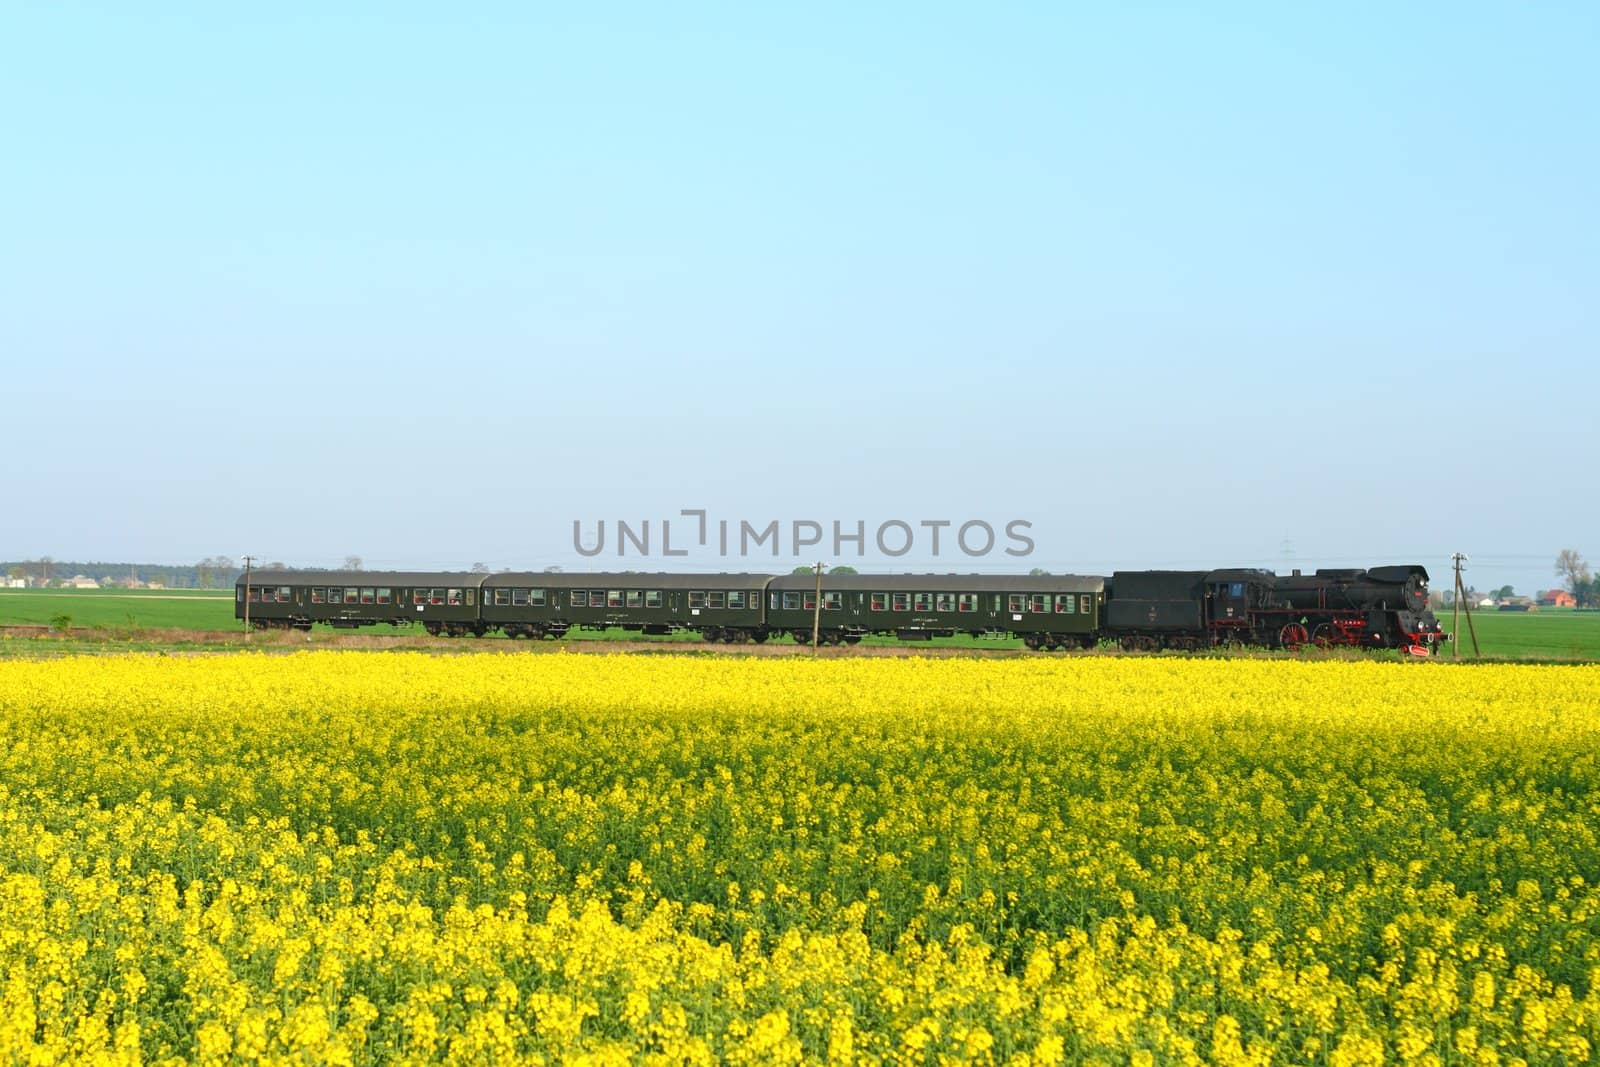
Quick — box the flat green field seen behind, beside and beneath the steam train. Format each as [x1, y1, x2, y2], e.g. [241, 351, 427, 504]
[0, 589, 1600, 661]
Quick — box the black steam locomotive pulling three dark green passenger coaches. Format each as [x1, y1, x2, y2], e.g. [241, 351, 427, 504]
[234, 563, 1448, 656]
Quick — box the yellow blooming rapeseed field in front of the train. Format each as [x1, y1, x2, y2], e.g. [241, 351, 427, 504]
[0, 653, 1600, 1065]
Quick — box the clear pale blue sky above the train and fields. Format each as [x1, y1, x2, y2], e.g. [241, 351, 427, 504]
[0, 2, 1600, 592]
